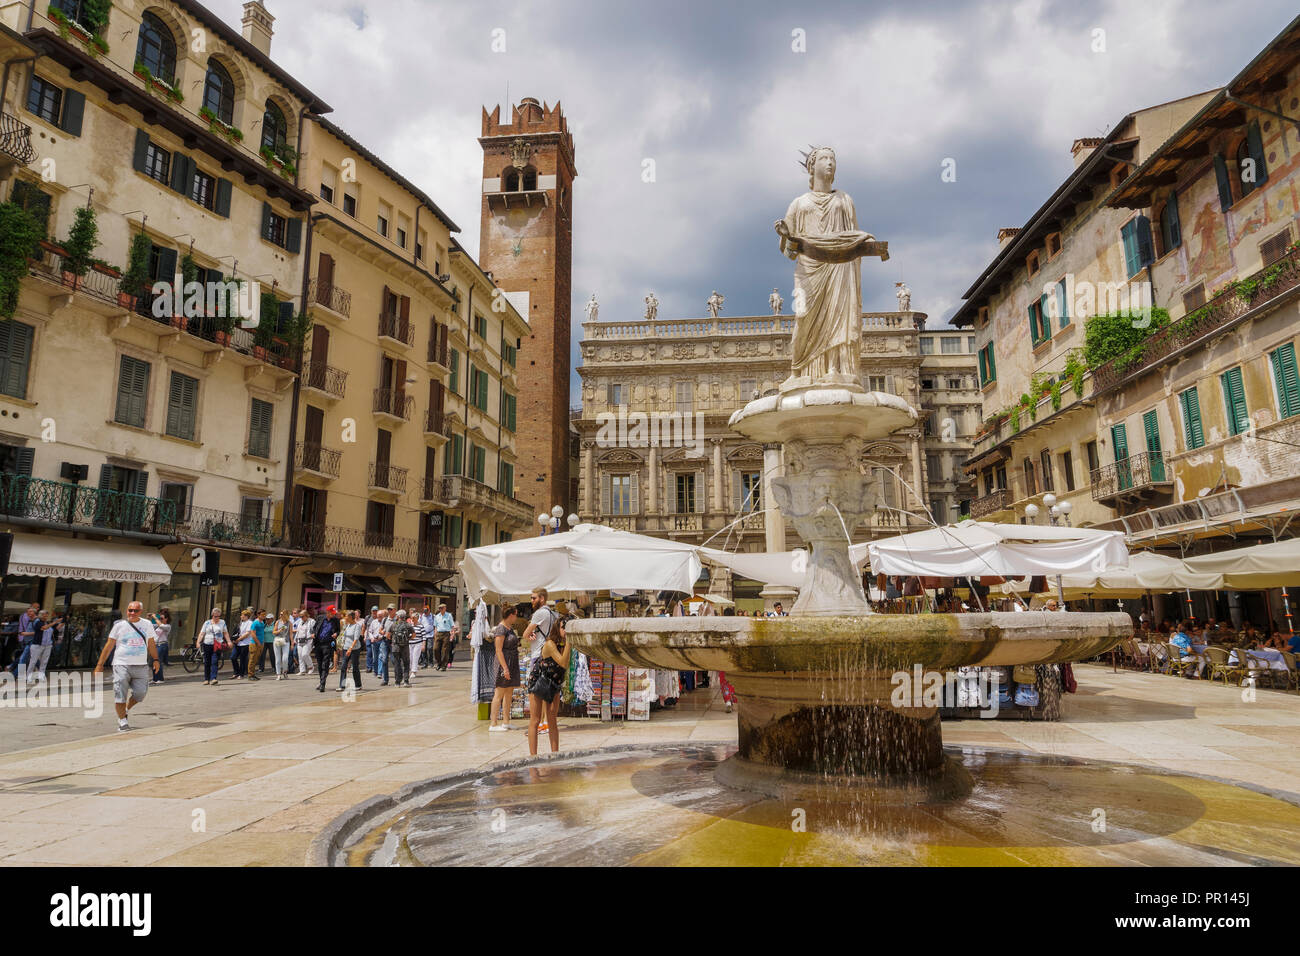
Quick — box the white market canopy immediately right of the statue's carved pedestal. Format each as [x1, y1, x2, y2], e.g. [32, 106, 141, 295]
[867, 522, 1128, 578]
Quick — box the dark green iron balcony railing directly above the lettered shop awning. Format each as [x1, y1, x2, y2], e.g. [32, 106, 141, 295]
[0, 472, 176, 535]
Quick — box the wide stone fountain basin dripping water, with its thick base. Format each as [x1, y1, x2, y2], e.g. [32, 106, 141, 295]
[567, 611, 1132, 803]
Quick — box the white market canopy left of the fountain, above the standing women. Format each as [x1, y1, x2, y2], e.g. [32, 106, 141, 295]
[459, 524, 702, 600]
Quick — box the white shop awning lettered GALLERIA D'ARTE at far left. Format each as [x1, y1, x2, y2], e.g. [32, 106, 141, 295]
[9, 532, 172, 584]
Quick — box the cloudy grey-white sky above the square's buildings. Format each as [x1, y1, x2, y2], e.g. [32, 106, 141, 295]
[248, 0, 1295, 388]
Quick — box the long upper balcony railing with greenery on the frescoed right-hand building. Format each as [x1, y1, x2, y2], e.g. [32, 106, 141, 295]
[1092, 248, 1300, 394]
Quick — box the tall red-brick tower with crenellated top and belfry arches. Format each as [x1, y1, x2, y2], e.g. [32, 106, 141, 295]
[478, 96, 577, 522]
